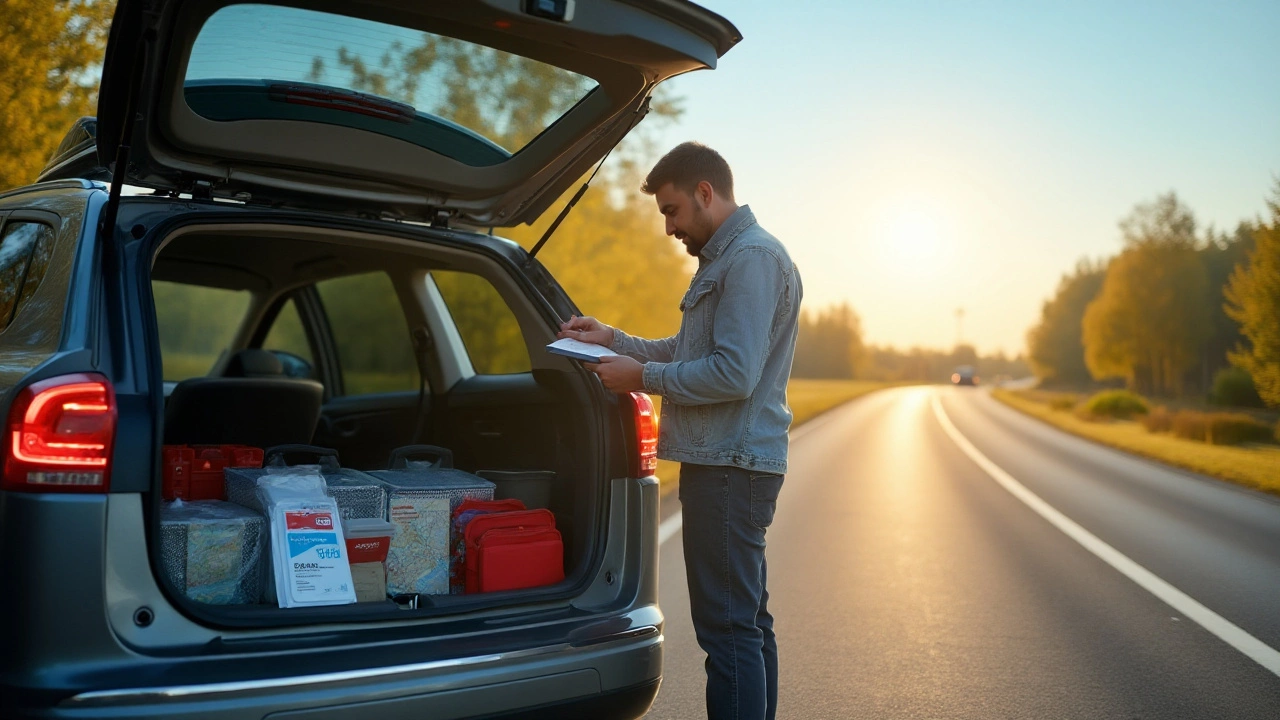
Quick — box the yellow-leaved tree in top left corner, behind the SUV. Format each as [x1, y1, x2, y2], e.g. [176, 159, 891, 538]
[0, 0, 115, 190]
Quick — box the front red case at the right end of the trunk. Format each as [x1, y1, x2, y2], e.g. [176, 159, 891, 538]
[466, 509, 564, 593]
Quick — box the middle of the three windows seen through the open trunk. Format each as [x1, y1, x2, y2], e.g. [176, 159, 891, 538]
[316, 273, 420, 395]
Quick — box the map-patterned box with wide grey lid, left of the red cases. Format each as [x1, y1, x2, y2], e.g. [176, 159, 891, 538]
[369, 461, 494, 594]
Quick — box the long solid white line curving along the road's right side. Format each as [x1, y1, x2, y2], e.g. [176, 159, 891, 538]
[931, 392, 1280, 675]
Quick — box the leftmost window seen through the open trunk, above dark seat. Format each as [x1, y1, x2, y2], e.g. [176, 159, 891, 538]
[151, 281, 250, 382]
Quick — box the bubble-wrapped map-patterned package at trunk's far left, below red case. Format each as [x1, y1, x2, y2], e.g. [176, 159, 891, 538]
[160, 500, 266, 605]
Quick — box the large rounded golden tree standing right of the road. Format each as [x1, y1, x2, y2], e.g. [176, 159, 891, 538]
[1082, 192, 1211, 396]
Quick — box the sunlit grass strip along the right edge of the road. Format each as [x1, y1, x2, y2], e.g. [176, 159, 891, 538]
[991, 389, 1280, 495]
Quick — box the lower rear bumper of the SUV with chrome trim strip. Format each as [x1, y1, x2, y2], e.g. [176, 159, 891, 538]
[5, 626, 663, 720]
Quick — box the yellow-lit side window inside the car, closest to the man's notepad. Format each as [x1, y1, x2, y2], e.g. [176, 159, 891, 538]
[431, 270, 531, 375]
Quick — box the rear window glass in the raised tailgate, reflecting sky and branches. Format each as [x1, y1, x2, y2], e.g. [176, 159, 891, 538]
[184, 4, 596, 167]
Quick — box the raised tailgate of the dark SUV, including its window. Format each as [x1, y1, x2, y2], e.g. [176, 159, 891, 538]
[97, 0, 740, 225]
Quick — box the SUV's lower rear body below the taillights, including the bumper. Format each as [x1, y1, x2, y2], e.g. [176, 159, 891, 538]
[0, 478, 663, 720]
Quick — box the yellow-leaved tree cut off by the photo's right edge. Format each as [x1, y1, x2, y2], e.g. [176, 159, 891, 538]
[1225, 181, 1280, 406]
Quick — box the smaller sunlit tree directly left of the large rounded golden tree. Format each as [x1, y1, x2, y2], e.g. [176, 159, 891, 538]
[1027, 259, 1106, 384]
